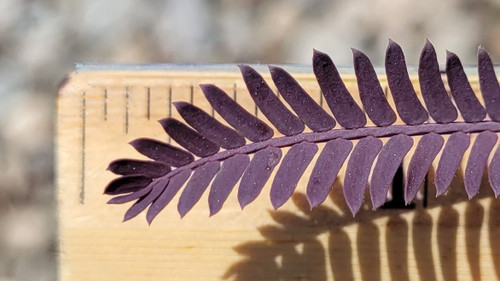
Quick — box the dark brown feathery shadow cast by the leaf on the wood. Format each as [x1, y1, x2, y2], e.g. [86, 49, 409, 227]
[226, 172, 500, 281]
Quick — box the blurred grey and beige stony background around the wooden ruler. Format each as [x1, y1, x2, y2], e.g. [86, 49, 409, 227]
[0, 0, 500, 280]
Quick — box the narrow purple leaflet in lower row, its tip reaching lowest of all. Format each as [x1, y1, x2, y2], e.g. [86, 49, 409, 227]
[146, 170, 191, 224]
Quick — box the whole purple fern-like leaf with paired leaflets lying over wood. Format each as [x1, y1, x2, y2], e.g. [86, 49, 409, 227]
[104, 41, 500, 223]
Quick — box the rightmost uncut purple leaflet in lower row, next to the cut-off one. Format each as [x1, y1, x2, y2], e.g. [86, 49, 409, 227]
[464, 131, 497, 199]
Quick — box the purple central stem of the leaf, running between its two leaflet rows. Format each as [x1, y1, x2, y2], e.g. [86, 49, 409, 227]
[163, 121, 500, 176]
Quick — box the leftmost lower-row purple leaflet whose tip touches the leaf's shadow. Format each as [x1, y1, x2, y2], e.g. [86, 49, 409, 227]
[271, 142, 318, 210]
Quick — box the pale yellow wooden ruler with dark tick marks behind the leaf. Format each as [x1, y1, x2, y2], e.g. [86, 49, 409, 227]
[56, 66, 500, 281]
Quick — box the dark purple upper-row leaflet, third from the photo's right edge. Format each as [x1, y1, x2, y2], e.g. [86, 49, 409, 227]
[418, 40, 458, 124]
